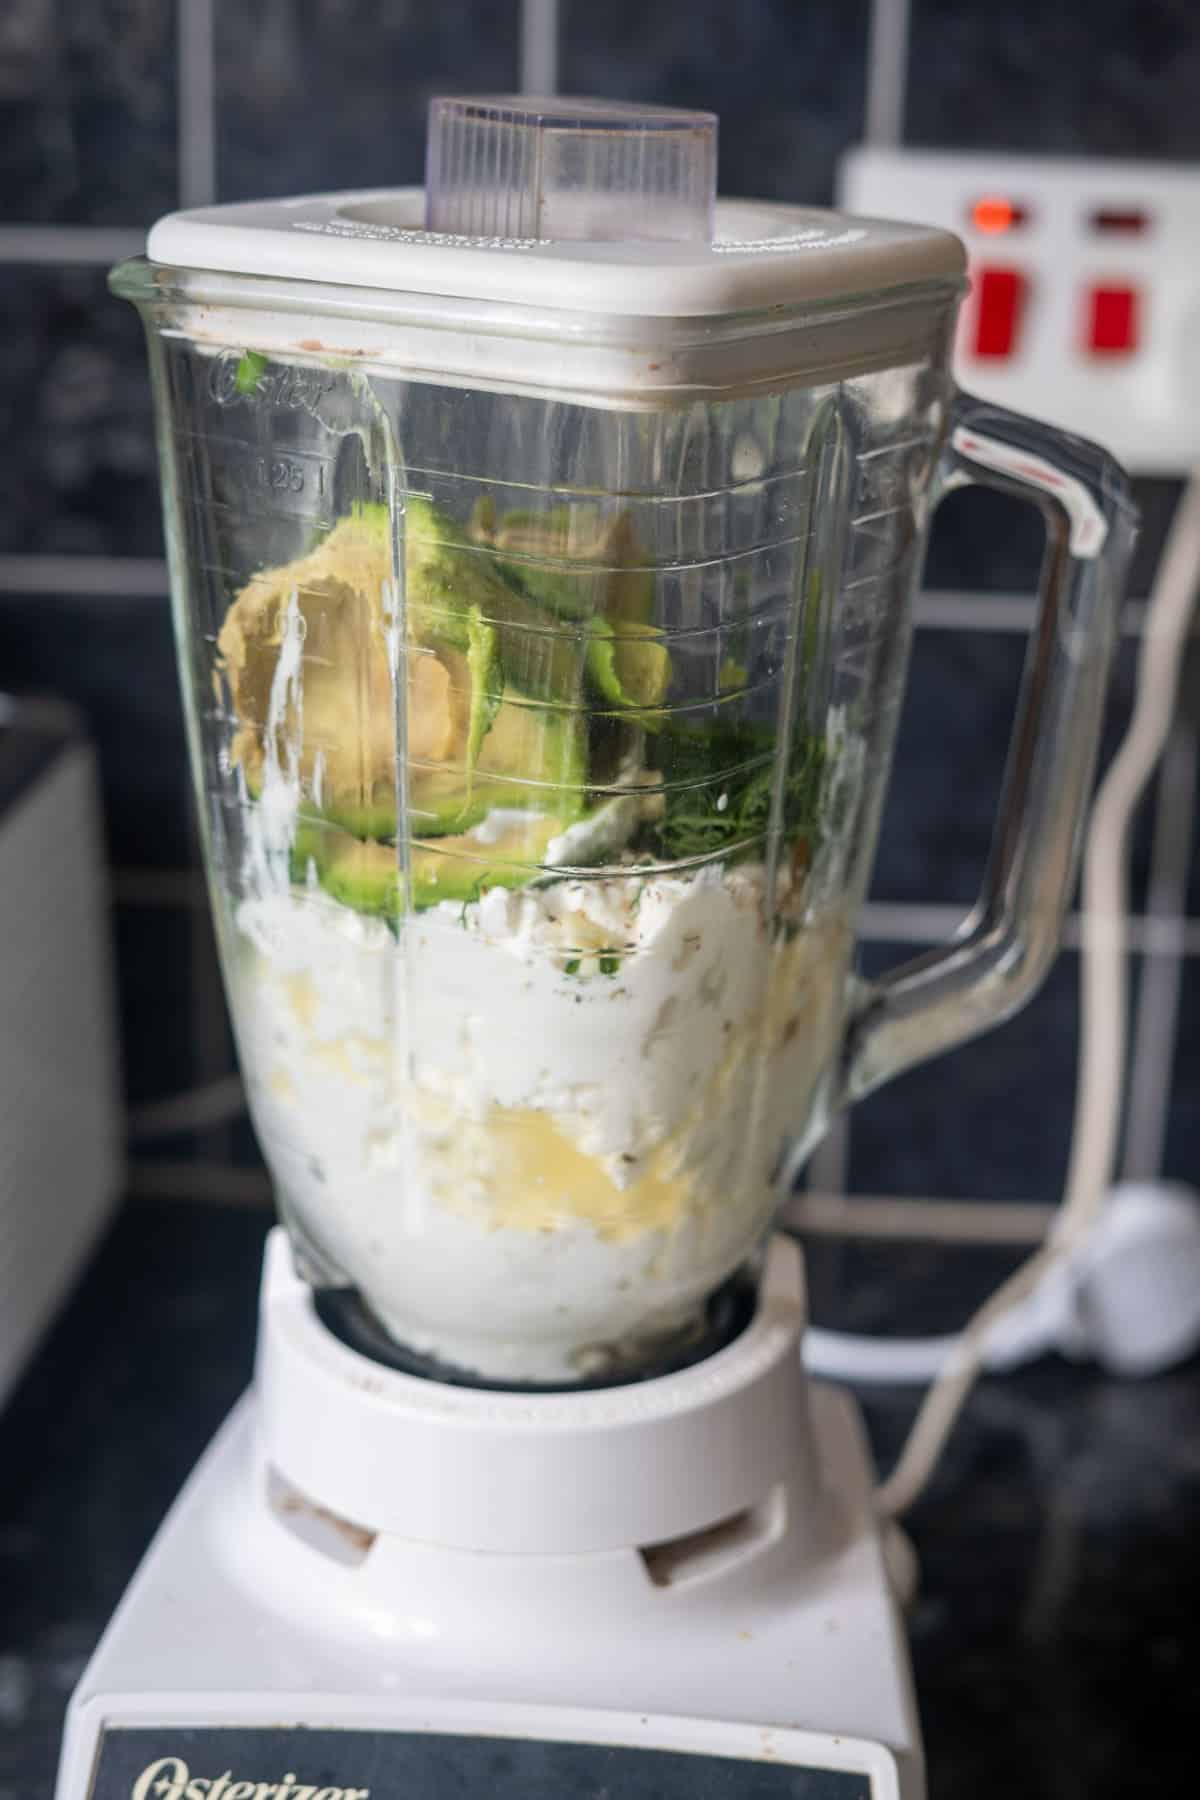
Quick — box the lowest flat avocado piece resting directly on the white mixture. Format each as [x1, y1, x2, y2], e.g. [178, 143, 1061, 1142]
[291, 817, 563, 918]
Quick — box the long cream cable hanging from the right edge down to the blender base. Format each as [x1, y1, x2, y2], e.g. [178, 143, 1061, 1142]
[852, 468, 1200, 1517]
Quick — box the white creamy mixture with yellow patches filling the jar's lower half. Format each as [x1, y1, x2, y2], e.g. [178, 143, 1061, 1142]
[230, 866, 849, 1381]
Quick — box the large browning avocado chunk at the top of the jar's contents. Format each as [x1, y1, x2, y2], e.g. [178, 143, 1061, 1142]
[218, 495, 587, 839]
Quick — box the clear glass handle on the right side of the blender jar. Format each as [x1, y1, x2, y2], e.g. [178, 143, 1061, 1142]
[833, 394, 1137, 1107]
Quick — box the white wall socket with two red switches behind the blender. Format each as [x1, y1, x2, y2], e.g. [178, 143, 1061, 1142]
[838, 146, 1200, 475]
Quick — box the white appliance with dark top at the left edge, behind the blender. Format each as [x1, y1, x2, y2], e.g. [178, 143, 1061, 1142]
[0, 697, 122, 1404]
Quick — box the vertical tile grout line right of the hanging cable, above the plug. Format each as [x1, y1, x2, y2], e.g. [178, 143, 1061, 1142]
[1121, 715, 1200, 1181]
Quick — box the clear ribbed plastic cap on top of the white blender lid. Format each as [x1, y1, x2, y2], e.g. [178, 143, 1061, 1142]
[425, 94, 716, 243]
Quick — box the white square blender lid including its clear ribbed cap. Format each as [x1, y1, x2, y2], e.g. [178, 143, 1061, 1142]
[148, 95, 966, 319]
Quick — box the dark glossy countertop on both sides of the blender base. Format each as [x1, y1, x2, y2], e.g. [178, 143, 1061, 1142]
[0, 1202, 1200, 1800]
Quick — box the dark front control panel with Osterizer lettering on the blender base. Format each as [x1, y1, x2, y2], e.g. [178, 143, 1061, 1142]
[88, 1724, 896, 1800]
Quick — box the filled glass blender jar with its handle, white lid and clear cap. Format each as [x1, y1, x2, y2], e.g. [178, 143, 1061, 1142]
[113, 97, 1133, 1386]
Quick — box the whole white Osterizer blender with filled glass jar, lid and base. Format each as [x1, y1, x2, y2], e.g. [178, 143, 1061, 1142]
[58, 97, 1133, 1800]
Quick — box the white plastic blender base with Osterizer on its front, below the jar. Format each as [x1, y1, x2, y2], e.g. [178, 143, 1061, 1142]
[56, 1233, 925, 1800]
